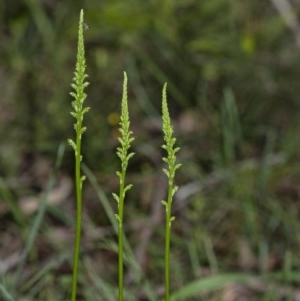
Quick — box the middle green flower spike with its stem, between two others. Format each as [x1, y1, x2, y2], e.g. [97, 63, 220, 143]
[113, 72, 134, 301]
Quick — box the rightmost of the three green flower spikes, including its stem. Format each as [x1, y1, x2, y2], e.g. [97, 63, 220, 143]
[162, 84, 180, 301]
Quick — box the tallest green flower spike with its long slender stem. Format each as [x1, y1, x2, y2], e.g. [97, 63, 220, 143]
[69, 10, 89, 301]
